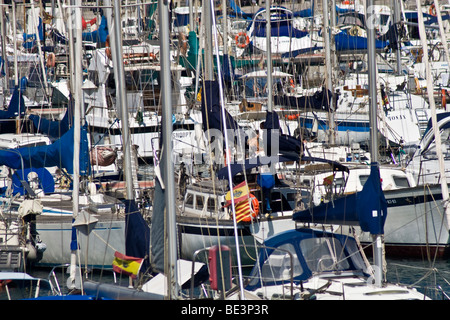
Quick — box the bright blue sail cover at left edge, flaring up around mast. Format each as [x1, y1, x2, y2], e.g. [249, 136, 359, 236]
[0, 125, 90, 175]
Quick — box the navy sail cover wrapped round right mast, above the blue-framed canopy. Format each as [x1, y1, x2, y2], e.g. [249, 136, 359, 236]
[292, 163, 387, 234]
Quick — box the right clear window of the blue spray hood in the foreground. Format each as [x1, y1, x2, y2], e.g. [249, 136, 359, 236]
[300, 237, 350, 272]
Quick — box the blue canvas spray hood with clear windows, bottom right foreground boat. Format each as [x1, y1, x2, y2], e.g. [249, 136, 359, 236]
[246, 228, 365, 290]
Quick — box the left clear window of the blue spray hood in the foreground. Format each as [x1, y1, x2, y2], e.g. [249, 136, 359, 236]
[261, 243, 303, 281]
